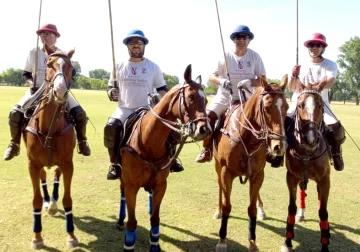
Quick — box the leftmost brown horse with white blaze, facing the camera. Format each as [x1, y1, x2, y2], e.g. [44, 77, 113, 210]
[24, 50, 78, 249]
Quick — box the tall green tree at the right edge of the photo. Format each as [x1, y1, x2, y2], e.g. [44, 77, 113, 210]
[337, 36, 360, 105]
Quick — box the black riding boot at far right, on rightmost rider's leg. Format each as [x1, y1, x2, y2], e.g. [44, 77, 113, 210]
[327, 121, 346, 171]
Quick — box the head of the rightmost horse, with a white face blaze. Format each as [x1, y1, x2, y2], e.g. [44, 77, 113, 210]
[295, 80, 326, 152]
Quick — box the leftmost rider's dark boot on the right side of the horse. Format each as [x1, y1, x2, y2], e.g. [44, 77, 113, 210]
[70, 106, 91, 156]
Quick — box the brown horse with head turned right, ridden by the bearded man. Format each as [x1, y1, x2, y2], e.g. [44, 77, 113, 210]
[121, 65, 211, 252]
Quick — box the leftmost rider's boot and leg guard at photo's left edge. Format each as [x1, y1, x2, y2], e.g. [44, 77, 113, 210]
[4, 109, 24, 160]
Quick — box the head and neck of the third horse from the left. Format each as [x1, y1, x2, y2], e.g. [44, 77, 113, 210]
[244, 75, 288, 156]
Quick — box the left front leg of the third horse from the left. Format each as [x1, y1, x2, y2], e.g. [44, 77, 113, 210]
[216, 167, 234, 252]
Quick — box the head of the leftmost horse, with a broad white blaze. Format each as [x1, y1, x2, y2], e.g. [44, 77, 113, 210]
[45, 50, 75, 104]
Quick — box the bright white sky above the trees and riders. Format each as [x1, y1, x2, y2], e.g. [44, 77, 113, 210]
[0, 0, 360, 83]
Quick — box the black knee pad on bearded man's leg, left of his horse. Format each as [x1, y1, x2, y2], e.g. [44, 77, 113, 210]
[104, 117, 124, 148]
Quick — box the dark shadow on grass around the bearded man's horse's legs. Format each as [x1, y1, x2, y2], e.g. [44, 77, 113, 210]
[52, 210, 243, 252]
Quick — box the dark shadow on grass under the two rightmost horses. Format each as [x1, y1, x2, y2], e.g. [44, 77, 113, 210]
[231, 216, 360, 252]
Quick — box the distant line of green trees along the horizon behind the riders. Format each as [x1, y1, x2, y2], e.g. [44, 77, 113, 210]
[0, 36, 360, 105]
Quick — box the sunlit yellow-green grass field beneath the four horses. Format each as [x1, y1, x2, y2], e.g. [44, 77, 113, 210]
[0, 87, 360, 252]
